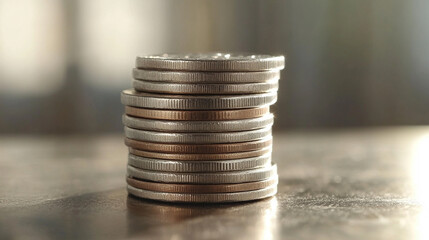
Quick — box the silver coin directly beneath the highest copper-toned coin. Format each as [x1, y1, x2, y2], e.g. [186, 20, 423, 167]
[122, 114, 274, 133]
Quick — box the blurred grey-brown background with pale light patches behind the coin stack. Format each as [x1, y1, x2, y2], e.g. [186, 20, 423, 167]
[0, 0, 429, 134]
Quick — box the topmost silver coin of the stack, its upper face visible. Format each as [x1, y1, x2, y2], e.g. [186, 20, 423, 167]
[136, 53, 285, 72]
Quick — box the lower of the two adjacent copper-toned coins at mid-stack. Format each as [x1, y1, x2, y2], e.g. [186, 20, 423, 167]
[130, 146, 271, 161]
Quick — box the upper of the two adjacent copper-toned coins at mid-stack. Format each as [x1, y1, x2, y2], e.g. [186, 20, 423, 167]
[125, 136, 272, 154]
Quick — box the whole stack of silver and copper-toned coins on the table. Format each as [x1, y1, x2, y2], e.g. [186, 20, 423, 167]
[121, 53, 284, 202]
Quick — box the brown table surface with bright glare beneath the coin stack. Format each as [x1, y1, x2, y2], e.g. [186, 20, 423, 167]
[0, 127, 429, 240]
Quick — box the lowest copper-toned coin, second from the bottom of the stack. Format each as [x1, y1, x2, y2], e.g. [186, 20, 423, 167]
[127, 176, 278, 193]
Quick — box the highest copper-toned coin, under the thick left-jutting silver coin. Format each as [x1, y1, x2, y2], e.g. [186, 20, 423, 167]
[125, 106, 270, 121]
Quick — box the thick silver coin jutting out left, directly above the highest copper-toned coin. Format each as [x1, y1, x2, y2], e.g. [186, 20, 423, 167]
[121, 89, 277, 110]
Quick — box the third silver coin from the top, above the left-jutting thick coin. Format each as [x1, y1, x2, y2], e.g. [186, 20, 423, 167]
[133, 80, 279, 95]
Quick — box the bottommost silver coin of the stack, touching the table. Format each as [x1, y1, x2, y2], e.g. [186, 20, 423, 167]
[127, 185, 277, 203]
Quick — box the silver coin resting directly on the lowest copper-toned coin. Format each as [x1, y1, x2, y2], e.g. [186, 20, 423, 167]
[127, 164, 277, 184]
